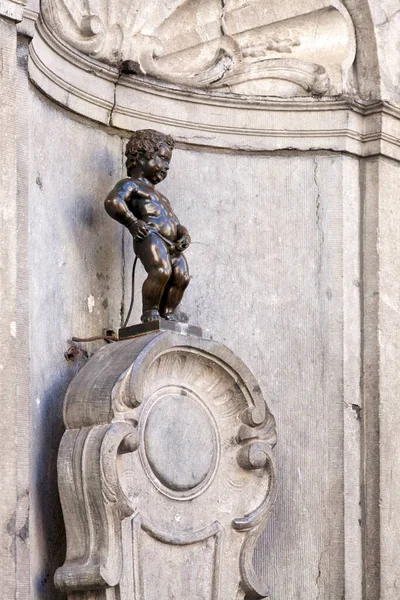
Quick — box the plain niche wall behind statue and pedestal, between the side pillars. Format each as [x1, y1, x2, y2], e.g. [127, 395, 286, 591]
[30, 113, 361, 598]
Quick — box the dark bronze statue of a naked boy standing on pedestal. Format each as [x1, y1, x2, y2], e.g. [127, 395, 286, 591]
[104, 129, 191, 323]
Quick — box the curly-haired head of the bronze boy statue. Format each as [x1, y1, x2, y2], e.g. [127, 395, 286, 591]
[125, 129, 175, 183]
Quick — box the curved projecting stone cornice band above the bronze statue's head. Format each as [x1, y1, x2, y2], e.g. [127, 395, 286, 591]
[29, 19, 400, 160]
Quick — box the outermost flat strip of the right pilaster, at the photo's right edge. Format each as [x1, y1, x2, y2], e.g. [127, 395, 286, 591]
[371, 160, 400, 600]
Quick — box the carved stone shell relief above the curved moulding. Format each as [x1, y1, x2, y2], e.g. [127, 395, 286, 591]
[42, 0, 356, 96]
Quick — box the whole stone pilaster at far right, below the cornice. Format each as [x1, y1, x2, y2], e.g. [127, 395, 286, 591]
[362, 158, 400, 600]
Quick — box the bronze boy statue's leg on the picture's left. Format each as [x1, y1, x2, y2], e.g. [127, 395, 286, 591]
[134, 233, 172, 323]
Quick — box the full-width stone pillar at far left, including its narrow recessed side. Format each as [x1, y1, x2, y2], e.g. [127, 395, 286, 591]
[0, 0, 29, 599]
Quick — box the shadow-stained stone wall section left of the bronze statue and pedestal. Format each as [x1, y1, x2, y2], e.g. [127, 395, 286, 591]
[29, 90, 123, 599]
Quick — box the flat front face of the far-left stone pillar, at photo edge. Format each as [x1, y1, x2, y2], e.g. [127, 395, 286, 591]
[0, 16, 21, 598]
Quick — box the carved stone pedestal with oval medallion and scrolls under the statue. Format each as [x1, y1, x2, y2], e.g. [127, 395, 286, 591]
[55, 332, 276, 600]
